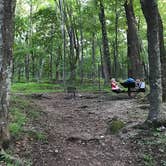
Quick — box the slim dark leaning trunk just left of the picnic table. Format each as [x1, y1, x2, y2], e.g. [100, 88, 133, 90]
[99, 0, 111, 83]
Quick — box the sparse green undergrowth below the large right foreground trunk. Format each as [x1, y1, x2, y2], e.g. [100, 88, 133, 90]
[136, 128, 166, 166]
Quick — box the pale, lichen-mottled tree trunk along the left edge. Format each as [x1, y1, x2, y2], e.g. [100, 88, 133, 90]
[0, 0, 16, 148]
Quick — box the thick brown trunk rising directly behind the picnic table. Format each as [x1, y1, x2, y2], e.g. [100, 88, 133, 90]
[124, 0, 144, 78]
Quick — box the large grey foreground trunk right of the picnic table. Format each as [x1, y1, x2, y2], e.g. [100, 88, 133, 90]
[140, 0, 162, 123]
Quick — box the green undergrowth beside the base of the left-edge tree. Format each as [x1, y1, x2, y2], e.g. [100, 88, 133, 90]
[0, 95, 47, 166]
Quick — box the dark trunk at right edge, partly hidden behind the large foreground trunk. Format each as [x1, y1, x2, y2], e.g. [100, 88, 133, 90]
[158, 11, 166, 102]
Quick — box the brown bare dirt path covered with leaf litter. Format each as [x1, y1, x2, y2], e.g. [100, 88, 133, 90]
[30, 93, 147, 166]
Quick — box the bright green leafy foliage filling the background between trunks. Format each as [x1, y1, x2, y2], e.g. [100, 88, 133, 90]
[13, 0, 166, 81]
